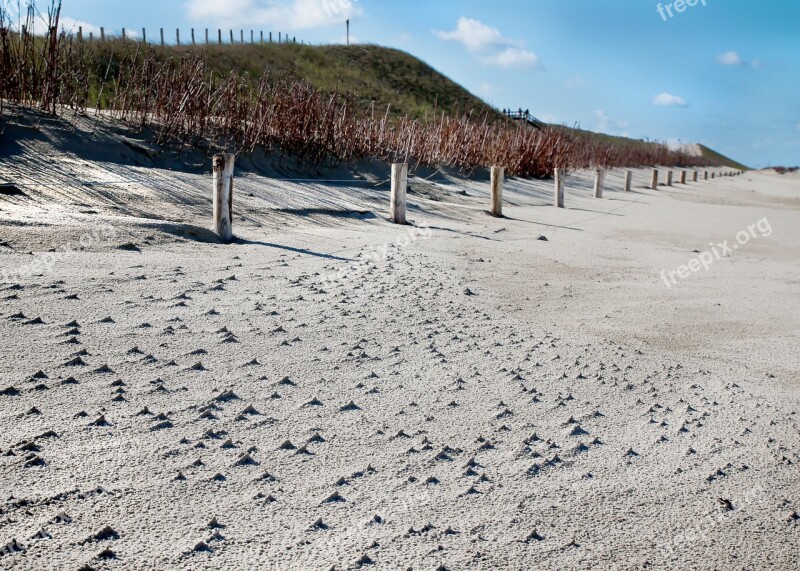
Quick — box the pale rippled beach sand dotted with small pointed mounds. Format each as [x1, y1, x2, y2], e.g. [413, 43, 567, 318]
[0, 115, 800, 570]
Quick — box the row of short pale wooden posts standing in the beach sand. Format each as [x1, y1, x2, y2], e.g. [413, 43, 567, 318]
[212, 153, 742, 242]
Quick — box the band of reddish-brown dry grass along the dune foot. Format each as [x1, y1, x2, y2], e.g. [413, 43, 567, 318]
[0, 0, 720, 177]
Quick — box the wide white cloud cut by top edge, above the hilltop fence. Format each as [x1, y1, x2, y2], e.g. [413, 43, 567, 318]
[184, 0, 363, 30]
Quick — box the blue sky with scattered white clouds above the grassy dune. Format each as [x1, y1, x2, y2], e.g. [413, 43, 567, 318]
[18, 0, 800, 167]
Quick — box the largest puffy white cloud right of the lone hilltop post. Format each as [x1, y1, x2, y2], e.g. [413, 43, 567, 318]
[433, 16, 540, 69]
